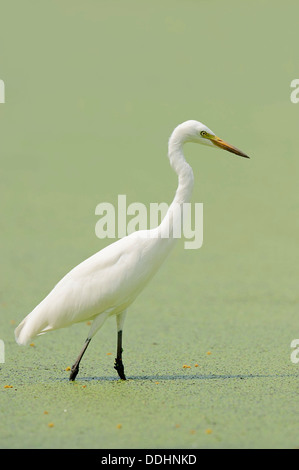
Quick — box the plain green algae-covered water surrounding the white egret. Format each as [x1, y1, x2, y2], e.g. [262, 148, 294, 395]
[0, 0, 299, 449]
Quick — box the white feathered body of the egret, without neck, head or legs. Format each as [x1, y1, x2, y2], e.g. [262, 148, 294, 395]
[15, 232, 172, 345]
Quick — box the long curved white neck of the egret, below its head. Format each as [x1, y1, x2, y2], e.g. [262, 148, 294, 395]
[158, 128, 194, 239]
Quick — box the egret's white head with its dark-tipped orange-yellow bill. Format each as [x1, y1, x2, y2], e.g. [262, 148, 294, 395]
[175, 121, 250, 158]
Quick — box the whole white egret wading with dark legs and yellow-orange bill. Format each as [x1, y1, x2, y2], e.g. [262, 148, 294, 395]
[15, 121, 249, 380]
